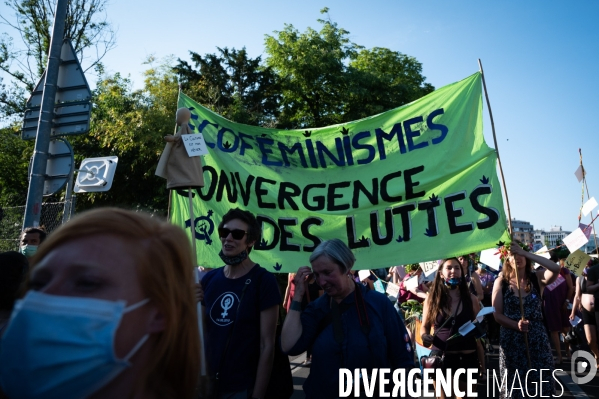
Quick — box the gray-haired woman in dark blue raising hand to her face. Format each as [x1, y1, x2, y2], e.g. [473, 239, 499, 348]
[281, 239, 414, 399]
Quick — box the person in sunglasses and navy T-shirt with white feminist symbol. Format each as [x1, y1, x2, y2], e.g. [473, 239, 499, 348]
[198, 208, 282, 399]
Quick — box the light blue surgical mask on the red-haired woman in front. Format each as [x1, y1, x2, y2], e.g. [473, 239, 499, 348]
[0, 291, 149, 399]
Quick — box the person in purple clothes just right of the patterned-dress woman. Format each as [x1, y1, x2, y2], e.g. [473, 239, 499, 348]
[543, 255, 574, 364]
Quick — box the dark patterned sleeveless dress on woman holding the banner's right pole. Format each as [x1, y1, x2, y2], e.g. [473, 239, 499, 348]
[499, 286, 555, 399]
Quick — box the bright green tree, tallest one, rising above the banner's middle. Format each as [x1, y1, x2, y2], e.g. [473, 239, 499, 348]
[265, 8, 361, 127]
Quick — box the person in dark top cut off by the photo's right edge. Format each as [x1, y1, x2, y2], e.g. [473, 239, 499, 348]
[569, 261, 599, 367]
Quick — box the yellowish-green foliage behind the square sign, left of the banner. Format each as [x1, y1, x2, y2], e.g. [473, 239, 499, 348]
[72, 59, 178, 214]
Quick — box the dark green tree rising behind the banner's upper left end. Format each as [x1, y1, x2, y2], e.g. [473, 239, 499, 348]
[174, 47, 280, 126]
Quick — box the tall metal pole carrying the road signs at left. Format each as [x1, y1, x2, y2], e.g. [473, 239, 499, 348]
[23, 0, 68, 229]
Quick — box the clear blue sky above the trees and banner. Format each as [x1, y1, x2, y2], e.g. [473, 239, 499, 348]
[2, 0, 599, 236]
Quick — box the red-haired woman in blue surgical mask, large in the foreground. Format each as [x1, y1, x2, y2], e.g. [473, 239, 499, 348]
[0, 208, 200, 399]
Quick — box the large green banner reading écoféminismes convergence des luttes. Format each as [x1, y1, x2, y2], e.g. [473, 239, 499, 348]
[171, 73, 509, 272]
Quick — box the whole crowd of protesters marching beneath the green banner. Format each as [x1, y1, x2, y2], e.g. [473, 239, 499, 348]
[0, 208, 599, 399]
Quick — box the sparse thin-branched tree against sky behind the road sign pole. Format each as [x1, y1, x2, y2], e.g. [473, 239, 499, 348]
[0, 0, 116, 120]
